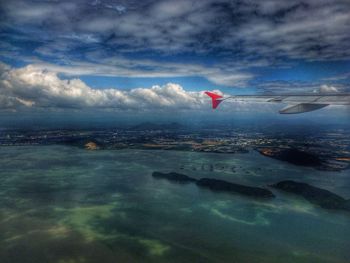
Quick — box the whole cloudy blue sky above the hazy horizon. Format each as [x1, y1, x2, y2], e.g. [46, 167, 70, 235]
[0, 0, 350, 123]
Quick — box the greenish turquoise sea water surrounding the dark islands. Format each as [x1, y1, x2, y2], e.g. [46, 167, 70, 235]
[0, 146, 350, 263]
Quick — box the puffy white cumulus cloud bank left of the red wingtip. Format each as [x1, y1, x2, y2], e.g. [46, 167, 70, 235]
[0, 64, 208, 111]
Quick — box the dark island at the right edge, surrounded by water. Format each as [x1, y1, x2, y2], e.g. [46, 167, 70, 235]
[272, 180, 350, 211]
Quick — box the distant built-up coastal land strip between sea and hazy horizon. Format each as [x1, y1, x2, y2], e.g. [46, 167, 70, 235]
[0, 122, 350, 171]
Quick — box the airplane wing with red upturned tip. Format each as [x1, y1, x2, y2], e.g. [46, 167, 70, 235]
[205, 91, 350, 114]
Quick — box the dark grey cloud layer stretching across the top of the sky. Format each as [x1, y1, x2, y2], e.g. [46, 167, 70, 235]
[1, 0, 350, 60]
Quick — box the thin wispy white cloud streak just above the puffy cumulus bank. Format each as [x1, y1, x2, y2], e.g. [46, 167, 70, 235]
[21, 55, 254, 87]
